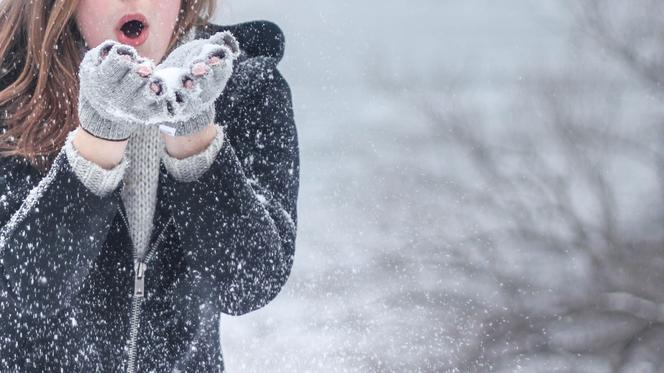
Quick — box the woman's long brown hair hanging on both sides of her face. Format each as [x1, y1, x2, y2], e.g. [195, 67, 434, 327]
[0, 0, 216, 172]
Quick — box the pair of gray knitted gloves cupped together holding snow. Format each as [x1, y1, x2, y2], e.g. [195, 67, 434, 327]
[78, 31, 240, 140]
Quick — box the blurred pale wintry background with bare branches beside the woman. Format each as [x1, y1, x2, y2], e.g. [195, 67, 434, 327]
[214, 0, 664, 372]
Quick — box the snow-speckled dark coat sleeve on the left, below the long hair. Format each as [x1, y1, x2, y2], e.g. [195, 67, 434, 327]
[0, 147, 120, 324]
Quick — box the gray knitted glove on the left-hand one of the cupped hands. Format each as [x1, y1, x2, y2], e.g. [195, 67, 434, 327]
[78, 40, 166, 140]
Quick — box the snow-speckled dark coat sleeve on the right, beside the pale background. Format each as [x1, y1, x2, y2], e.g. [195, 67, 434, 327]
[161, 67, 299, 315]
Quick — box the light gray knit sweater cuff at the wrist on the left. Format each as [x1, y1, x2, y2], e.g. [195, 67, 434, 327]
[64, 128, 129, 197]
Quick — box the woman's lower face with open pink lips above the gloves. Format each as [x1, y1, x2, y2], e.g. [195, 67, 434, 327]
[75, 0, 182, 64]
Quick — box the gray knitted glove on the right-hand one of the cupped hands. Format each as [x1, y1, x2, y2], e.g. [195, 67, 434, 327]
[153, 31, 240, 136]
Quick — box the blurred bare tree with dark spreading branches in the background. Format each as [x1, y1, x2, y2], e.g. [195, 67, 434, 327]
[364, 0, 664, 372]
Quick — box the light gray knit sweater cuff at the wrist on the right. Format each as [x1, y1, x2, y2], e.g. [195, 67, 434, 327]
[162, 123, 224, 182]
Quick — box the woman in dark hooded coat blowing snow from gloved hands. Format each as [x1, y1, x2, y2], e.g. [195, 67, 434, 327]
[0, 0, 299, 372]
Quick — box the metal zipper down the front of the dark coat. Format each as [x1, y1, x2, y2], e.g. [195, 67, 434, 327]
[120, 203, 173, 373]
